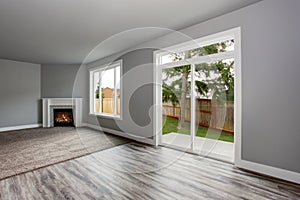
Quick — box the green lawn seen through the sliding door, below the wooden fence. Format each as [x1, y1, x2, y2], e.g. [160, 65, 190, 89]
[163, 117, 234, 142]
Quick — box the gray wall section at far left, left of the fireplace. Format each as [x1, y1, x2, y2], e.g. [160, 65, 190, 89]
[0, 59, 41, 127]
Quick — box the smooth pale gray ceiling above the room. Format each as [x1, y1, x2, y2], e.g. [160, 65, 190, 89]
[0, 0, 260, 64]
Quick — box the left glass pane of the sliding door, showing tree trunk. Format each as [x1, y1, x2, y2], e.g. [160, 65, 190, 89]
[162, 65, 191, 149]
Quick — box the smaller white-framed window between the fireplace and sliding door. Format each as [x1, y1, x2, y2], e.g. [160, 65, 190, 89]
[90, 60, 122, 118]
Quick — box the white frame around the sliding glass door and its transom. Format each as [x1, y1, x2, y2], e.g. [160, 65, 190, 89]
[153, 27, 242, 166]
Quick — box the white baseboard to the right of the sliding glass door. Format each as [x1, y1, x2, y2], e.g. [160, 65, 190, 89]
[235, 160, 300, 184]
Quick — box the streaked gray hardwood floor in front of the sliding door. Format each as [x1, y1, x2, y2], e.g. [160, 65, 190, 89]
[0, 143, 300, 200]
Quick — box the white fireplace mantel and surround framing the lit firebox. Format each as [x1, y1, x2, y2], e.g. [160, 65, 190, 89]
[42, 98, 82, 127]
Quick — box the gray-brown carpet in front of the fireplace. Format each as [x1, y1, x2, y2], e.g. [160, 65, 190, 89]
[0, 127, 129, 180]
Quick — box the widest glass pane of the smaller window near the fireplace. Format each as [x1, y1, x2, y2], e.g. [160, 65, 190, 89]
[101, 68, 115, 114]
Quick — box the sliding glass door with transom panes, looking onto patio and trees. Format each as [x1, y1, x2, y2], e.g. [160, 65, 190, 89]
[156, 30, 235, 162]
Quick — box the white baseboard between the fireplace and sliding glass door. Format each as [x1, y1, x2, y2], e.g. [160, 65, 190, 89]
[82, 123, 155, 145]
